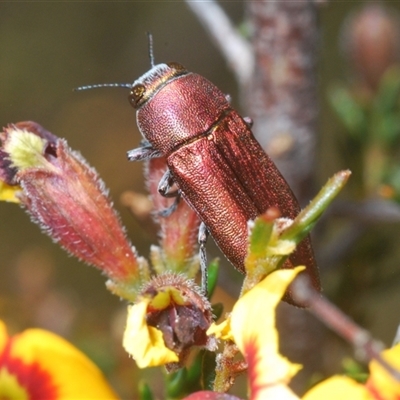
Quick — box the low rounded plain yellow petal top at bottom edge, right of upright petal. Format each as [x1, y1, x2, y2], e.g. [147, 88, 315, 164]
[302, 376, 375, 400]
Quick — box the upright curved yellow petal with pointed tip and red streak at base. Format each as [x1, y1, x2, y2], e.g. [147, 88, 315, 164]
[231, 267, 304, 399]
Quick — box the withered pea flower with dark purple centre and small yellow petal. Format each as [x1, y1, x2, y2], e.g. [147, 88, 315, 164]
[123, 273, 216, 371]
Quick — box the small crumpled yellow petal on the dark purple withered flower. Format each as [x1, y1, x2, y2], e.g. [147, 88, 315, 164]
[123, 298, 179, 368]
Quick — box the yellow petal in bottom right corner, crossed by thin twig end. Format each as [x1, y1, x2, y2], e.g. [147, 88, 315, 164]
[366, 344, 400, 400]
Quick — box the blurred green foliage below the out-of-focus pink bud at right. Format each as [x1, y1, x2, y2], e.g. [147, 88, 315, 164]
[329, 64, 400, 201]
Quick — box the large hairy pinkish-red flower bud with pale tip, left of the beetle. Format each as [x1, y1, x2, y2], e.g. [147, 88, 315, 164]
[0, 122, 146, 292]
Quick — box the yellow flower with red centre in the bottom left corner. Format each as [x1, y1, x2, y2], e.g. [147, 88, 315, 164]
[0, 321, 118, 400]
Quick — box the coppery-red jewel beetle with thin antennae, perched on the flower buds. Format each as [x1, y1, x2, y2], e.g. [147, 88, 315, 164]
[79, 43, 320, 302]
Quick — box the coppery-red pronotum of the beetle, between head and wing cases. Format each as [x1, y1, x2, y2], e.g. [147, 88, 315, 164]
[137, 72, 230, 155]
